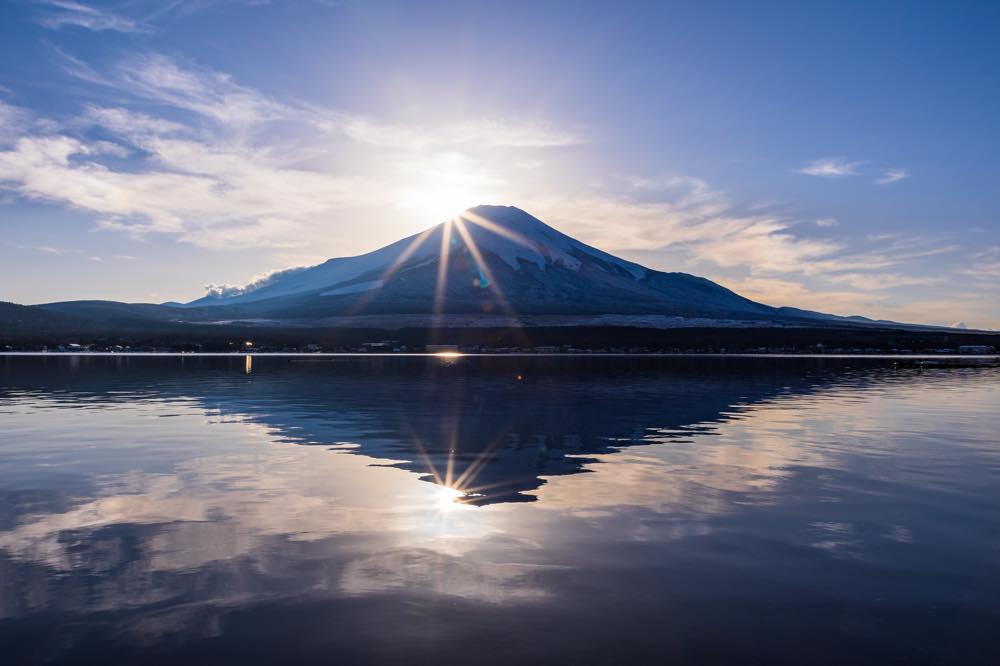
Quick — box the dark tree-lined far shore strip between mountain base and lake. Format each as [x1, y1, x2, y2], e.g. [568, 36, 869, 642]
[0, 326, 1000, 353]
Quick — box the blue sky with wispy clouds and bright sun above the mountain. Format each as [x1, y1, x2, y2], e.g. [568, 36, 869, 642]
[0, 0, 1000, 328]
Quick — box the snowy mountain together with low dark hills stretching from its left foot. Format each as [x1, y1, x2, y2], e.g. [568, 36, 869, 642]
[0, 206, 968, 337]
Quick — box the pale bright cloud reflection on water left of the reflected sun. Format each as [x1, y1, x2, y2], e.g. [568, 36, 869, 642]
[0, 405, 500, 571]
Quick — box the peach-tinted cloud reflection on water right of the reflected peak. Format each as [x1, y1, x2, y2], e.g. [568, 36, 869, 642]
[534, 396, 843, 519]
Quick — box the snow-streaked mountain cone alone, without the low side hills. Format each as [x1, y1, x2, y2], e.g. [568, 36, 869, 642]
[184, 206, 784, 321]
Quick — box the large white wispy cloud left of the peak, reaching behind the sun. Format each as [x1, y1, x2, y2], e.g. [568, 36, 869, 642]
[0, 53, 584, 250]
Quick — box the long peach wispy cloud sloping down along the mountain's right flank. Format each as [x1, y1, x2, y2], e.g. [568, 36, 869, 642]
[532, 182, 984, 324]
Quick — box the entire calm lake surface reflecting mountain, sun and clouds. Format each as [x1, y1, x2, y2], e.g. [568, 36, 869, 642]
[0, 357, 1000, 665]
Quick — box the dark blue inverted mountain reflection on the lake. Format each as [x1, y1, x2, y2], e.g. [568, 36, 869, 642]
[5, 357, 884, 504]
